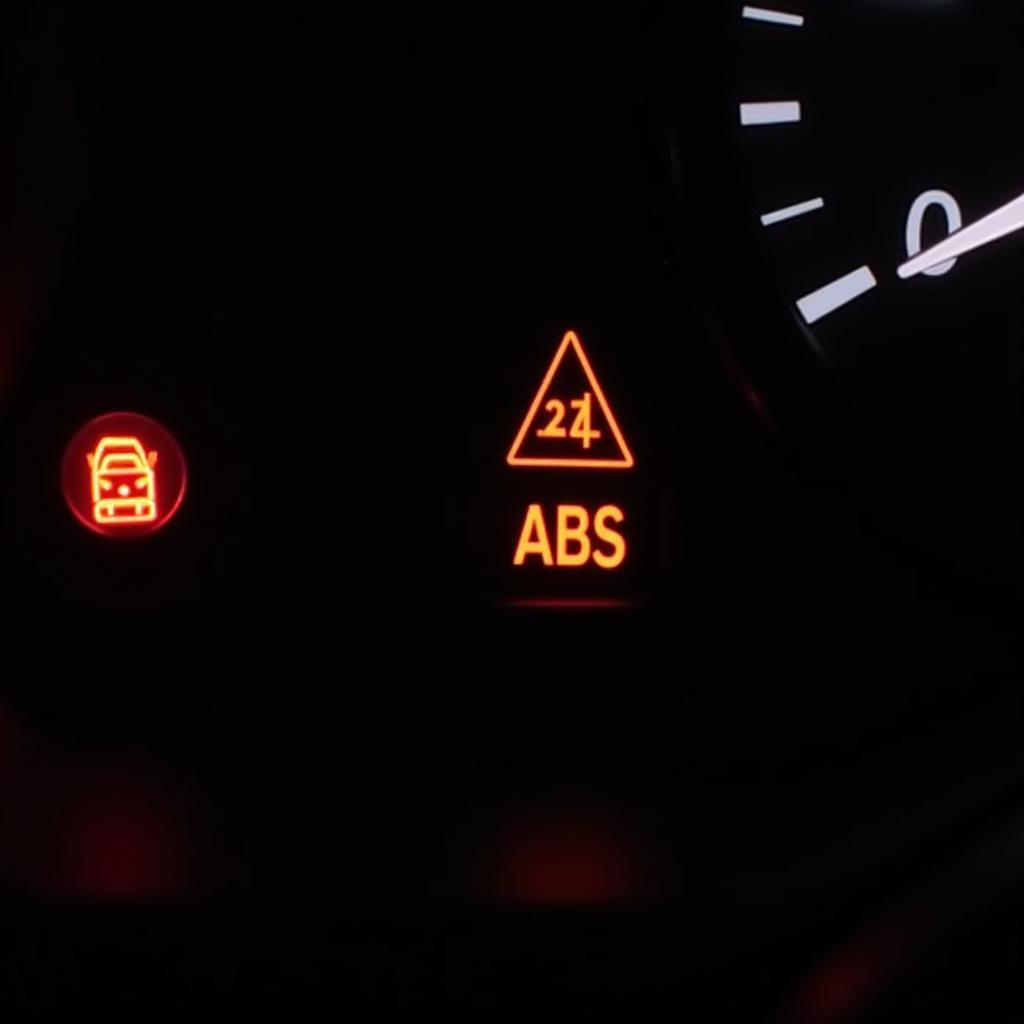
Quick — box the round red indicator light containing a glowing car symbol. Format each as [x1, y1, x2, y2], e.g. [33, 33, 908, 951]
[60, 413, 186, 539]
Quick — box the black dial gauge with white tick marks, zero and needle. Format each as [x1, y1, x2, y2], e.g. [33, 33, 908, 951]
[676, 0, 1024, 574]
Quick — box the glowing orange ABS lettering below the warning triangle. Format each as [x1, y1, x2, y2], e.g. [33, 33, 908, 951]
[512, 505, 626, 569]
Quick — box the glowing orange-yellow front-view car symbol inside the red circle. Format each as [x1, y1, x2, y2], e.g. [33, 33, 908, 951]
[85, 437, 158, 526]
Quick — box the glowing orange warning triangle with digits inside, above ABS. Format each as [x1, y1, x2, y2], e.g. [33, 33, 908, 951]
[507, 331, 633, 469]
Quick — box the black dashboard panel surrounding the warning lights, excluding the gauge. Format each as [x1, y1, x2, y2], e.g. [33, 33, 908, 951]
[0, 4, 1020, 1020]
